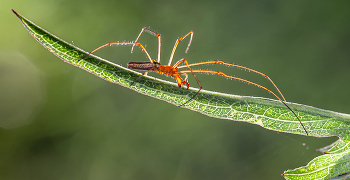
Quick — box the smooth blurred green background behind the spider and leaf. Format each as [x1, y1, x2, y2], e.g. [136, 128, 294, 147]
[0, 0, 350, 180]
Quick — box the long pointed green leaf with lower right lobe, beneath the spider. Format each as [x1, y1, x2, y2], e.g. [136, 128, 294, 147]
[12, 10, 350, 179]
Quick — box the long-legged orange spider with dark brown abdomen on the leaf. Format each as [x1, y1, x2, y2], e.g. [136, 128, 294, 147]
[82, 27, 309, 135]
